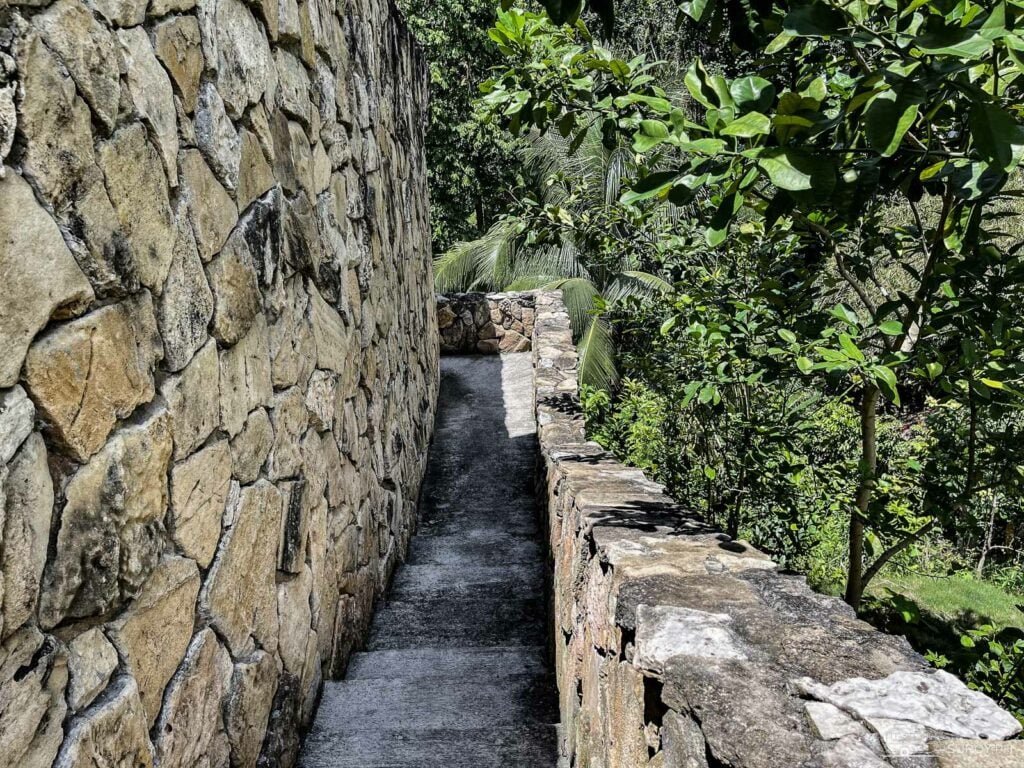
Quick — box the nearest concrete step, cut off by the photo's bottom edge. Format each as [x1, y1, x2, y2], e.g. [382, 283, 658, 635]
[299, 725, 558, 768]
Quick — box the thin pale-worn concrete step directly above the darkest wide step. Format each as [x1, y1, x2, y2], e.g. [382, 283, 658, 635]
[388, 563, 544, 600]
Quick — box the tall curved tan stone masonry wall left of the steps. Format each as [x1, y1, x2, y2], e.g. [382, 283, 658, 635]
[0, 0, 438, 768]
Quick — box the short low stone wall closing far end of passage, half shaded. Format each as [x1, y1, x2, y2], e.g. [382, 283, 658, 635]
[437, 292, 536, 354]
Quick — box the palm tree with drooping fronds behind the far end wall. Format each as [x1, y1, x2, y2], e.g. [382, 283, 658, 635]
[434, 129, 675, 389]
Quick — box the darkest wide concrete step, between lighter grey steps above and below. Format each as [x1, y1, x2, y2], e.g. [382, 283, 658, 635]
[367, 593, 547, 650]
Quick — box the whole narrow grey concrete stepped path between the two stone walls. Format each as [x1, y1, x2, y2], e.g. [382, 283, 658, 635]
[301, 354, 558, 768]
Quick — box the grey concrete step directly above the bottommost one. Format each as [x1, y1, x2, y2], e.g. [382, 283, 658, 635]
[310, 675, 558, 739]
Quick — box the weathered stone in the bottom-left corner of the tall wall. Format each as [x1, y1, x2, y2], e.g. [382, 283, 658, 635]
[0, 627, 68, 768]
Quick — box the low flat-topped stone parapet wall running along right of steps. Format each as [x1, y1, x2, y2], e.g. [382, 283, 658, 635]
[534, 293, 1024, 768]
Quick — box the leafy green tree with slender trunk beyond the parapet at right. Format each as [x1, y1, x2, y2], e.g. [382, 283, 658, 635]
[484, 0, 1024, 605]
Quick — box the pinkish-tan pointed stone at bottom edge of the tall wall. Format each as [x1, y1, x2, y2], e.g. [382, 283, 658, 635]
[154, 629, 232, 768]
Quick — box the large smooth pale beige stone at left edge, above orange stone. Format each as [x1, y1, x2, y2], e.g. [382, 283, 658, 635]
[0, 172, 93, 387]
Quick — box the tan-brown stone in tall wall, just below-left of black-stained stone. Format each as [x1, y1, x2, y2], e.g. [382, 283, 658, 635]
[207, 223, 263, 344]
